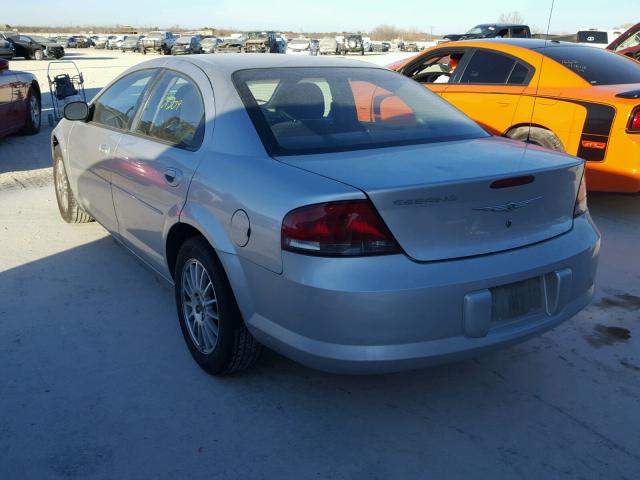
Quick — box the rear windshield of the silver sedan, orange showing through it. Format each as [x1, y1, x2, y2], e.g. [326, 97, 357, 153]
[233, 67, 488, 155]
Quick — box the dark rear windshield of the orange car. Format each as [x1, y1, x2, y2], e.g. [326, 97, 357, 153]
[540, 46, 640, 85]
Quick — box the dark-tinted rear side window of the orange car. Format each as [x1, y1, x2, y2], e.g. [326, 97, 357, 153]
[460, 50, 529, 85]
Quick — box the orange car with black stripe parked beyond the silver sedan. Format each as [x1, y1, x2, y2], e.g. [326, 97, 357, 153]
[389, 39, 640, 193]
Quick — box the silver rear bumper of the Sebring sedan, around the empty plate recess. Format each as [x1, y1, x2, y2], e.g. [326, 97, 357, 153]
[221, 215, 600, 373]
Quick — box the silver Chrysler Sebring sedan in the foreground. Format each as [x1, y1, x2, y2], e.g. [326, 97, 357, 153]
[52, 55, 600, 374]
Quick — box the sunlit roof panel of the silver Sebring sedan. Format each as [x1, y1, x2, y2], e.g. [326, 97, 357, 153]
[181, 53, 382, 75]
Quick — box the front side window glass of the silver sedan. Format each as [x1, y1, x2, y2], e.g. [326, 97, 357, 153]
[91, 70, 155, 130]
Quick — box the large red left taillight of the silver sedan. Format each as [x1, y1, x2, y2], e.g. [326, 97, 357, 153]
[282, 200, 401, 257]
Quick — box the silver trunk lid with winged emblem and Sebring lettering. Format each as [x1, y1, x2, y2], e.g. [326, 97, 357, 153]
[278, 138, 583, 261]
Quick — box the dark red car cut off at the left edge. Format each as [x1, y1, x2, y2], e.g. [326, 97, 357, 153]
[0, 59, 41, 137]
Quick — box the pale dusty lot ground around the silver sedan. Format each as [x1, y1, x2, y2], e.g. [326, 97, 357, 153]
[0, 50, 640, 479]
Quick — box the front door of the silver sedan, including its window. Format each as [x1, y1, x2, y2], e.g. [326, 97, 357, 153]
[68, 69, 157, 232]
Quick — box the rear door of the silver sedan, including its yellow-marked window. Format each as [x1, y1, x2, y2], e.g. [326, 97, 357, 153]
[112, 62, 214, 273]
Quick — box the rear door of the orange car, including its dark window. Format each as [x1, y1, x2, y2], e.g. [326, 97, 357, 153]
[443, 49, 534, 135]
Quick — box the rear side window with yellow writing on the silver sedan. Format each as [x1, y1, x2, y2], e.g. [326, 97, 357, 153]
[136, 72, 204, 150]
